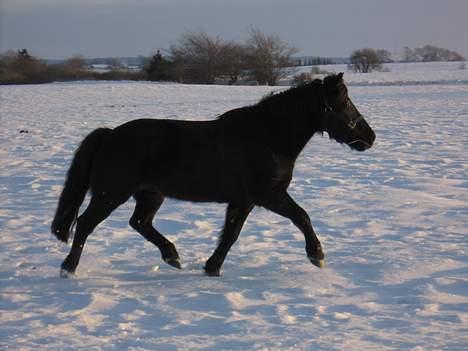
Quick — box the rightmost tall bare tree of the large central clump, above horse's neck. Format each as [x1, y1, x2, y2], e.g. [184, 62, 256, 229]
[247, 28, 297, 85]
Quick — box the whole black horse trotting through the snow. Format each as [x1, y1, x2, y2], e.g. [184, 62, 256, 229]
[51, 73, 375, 276]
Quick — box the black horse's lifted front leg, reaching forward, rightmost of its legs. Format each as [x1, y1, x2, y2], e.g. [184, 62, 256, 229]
[259, 191, 325, 268]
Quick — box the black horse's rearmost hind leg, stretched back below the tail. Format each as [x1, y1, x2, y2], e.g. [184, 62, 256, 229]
[61, 196, 127, 277]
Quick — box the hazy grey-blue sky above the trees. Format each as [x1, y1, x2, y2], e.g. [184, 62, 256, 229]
[0, 0, 468, 59]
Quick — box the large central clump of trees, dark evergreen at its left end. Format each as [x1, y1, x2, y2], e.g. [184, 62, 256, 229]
[145, 28, 297, 85]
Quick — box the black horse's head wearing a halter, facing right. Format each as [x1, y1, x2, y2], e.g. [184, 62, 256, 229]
[322, 73, 375, 151]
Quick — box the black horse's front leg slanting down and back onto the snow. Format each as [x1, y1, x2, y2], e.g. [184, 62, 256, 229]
[205, 204, 253, 276]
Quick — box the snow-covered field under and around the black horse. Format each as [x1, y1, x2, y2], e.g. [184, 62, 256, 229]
[0, 64, 468, 351]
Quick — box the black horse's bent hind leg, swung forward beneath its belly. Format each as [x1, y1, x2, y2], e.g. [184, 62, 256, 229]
[130, 191, 181, 269]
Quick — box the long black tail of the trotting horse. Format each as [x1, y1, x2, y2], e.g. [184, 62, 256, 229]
[51, 128, 112, 242]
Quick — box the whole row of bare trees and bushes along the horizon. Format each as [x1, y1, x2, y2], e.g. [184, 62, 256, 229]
[0, 33, 466, 85]
